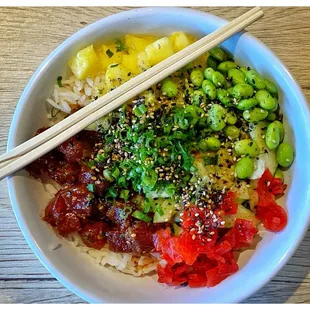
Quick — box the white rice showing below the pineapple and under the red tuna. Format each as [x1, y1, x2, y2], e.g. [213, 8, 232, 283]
[43, 75, 163, 277]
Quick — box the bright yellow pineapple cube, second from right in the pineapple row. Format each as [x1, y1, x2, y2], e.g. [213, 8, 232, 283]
[145, 37, 173, 66]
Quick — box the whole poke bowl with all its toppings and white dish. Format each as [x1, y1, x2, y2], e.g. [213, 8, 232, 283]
[8, 8, 310, 303]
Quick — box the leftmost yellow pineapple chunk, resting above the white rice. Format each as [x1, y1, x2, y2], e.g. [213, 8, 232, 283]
[68, 45, 99, 80]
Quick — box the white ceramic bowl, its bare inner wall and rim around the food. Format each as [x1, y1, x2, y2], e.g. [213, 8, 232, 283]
[8, 8, 310, 303]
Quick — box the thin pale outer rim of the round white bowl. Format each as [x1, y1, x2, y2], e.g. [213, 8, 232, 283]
[7, 7, 310, 303]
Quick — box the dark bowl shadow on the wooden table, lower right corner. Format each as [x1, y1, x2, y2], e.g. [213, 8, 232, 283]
[243, 230, 310, 304]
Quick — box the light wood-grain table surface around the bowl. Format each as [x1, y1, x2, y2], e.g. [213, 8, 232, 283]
[0, 7, 310, 304]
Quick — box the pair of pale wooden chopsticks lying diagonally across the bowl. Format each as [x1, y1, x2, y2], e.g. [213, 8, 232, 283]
[0, 7, 264, 180]
